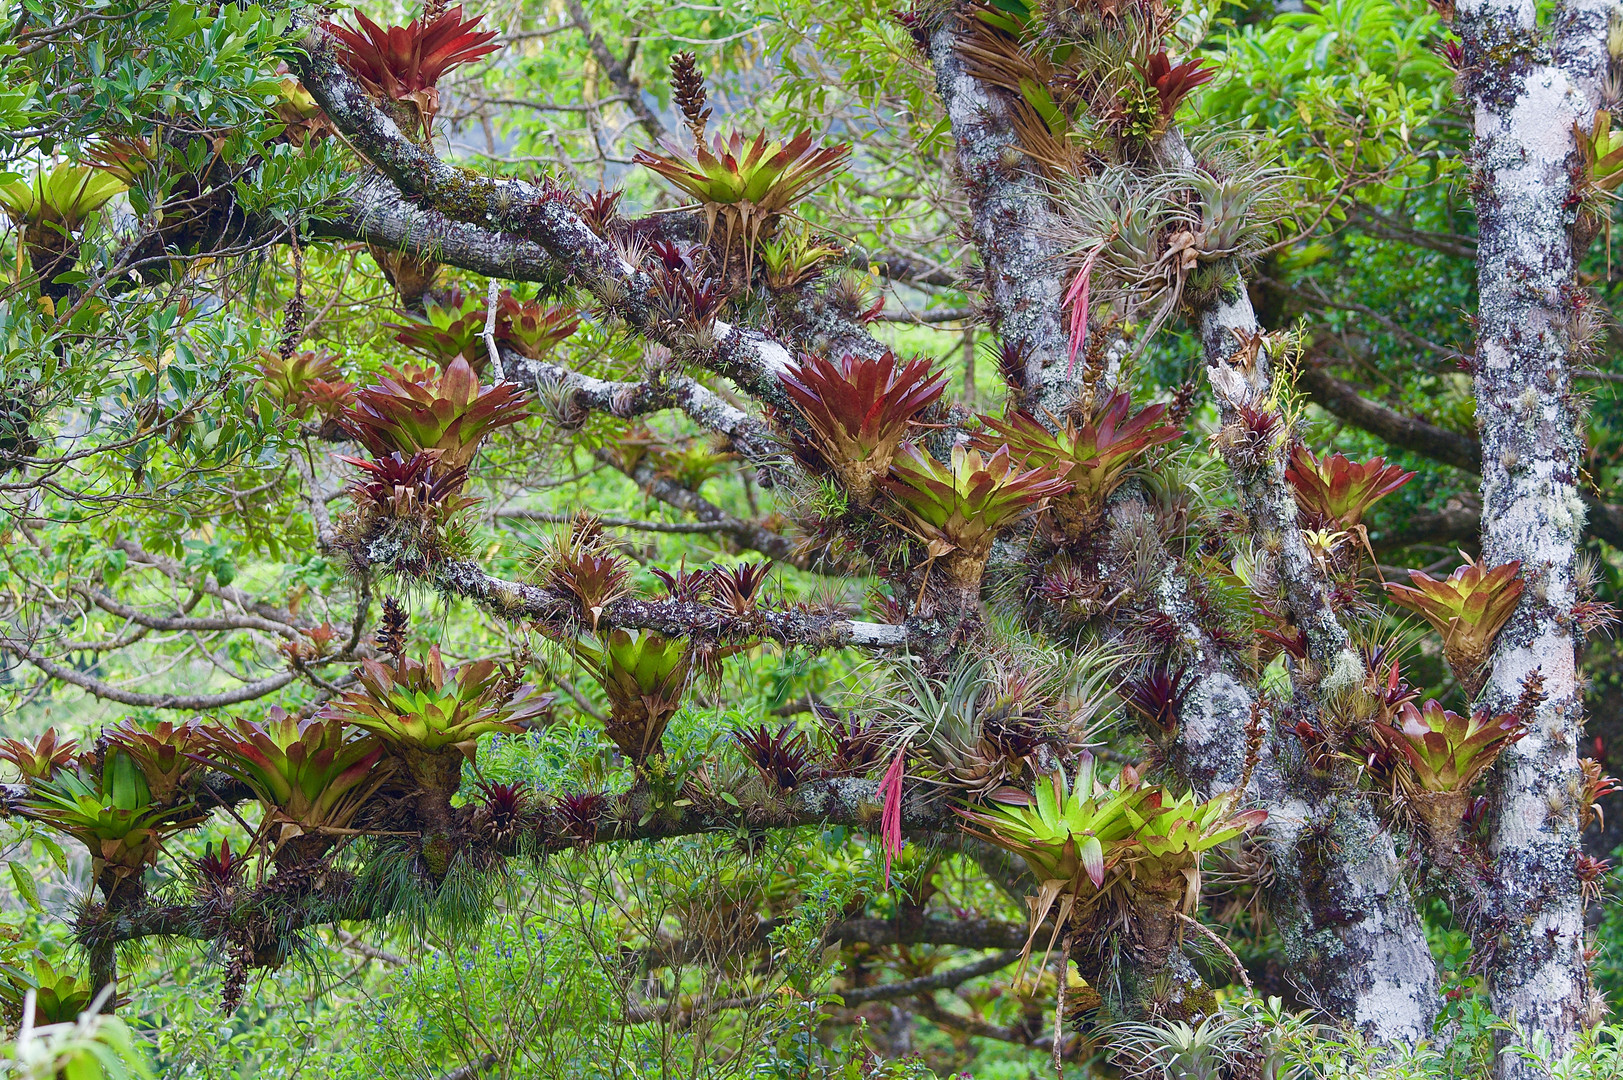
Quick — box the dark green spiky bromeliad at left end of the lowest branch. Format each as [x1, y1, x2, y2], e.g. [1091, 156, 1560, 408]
[15, 745, 208, 898]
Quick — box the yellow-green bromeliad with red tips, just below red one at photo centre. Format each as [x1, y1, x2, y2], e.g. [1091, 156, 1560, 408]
[885, 443, 1071, 591]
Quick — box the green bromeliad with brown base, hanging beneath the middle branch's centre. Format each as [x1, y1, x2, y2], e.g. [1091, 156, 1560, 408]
[575, 629, 693, 765]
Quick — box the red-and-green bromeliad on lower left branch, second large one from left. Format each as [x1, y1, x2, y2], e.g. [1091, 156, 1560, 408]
[200, 705, 390, 866]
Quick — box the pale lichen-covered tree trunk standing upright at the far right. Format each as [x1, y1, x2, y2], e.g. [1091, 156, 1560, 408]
[1457, 0, 1610, 1058]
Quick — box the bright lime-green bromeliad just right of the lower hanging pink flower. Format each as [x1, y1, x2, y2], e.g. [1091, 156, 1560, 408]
[958, 752, 1159, 965]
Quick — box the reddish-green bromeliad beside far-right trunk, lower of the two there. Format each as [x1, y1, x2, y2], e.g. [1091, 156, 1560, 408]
[1373, 702, 1527, 846]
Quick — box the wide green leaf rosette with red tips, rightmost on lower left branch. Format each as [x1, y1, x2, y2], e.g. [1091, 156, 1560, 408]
[316, 645, 547, 760]
